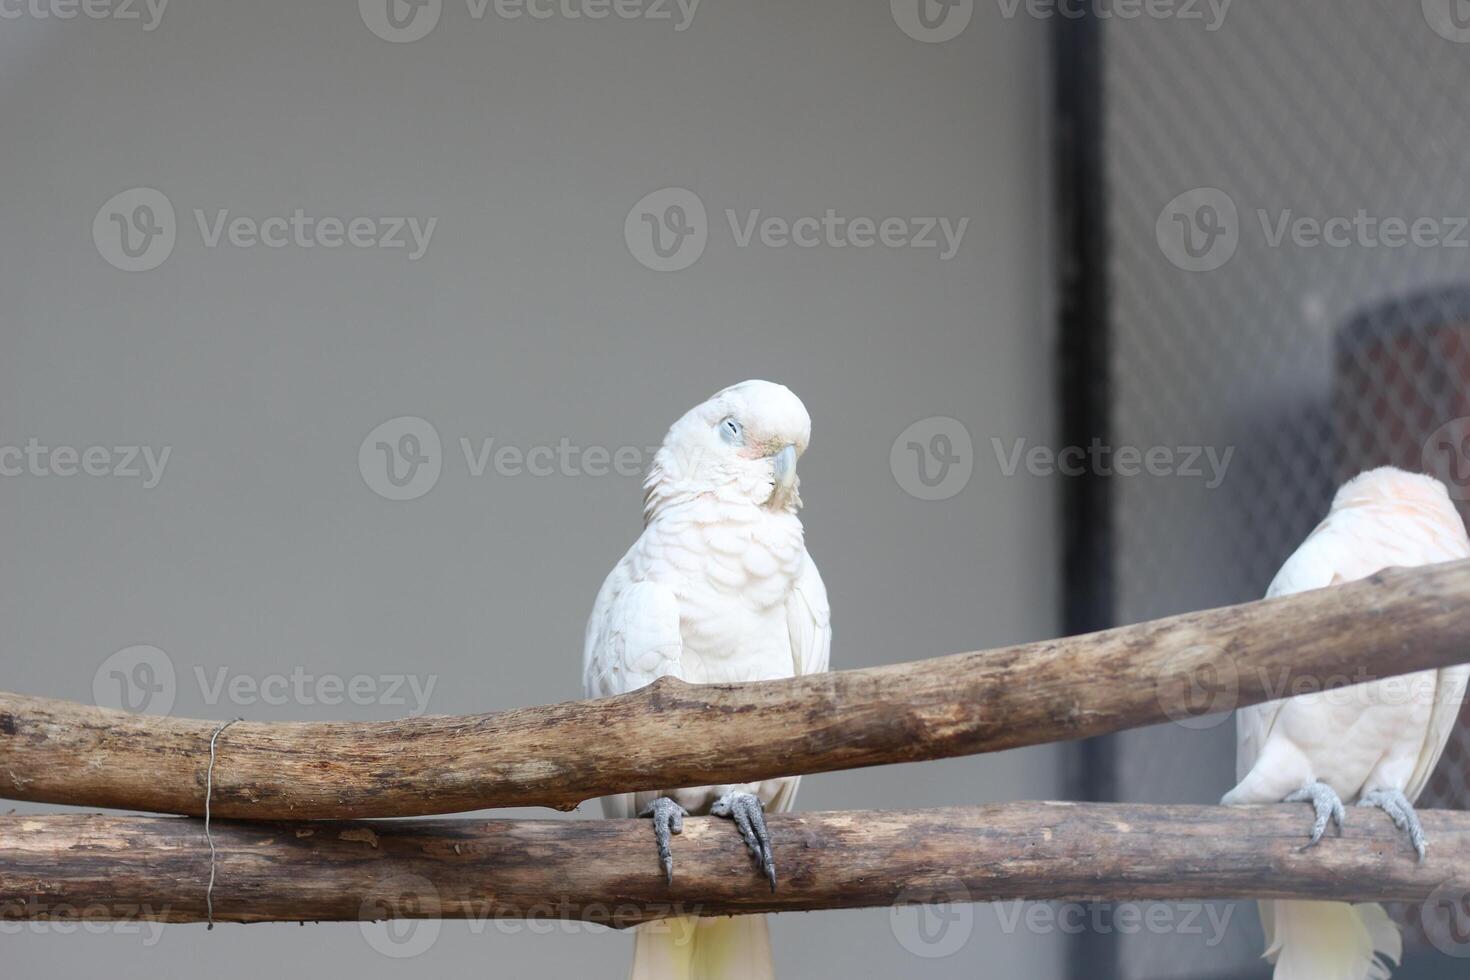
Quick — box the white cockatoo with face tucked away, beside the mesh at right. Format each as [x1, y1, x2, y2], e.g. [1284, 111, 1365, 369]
[1222, 467, 1470, 980]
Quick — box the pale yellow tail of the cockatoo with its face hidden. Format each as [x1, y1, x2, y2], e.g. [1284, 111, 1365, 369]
[1261, 902, 1404, 980]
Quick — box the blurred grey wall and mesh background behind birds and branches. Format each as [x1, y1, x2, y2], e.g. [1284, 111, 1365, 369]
[0, 0, 1470, 980]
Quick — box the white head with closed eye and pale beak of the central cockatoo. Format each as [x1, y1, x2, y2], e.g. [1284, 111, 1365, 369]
[644, 381, 811, 519]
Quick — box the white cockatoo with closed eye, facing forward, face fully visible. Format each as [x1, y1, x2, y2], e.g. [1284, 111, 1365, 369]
[582, 381, 832, 980]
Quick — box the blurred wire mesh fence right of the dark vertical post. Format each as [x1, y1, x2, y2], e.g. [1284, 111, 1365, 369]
[1103, 0, 1470, 979]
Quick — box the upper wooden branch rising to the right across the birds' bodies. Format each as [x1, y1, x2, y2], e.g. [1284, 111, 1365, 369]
[0, 561, 1470, 820]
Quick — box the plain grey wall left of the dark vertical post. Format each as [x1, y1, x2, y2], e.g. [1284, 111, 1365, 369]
[0, 0, 1064, 980]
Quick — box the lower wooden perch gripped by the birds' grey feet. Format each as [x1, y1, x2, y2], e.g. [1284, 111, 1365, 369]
[0, 802, 1470, 926]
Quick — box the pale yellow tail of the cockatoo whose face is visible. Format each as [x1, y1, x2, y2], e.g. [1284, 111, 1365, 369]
[629, 915, 776, 980]
